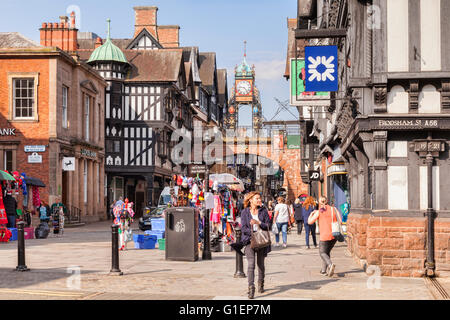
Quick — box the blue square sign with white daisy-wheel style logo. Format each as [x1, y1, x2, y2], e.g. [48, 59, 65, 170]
[305, 46, 338, 92]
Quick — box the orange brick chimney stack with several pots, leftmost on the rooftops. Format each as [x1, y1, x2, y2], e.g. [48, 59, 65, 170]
[39, 12, 78, 52]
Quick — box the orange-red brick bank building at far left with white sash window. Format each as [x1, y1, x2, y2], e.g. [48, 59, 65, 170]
[0, 30, 106, 221]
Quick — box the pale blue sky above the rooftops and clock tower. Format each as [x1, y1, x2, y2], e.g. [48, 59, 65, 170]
[0, 0, 298, 125]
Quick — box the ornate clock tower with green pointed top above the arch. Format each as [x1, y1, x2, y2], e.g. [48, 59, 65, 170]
[225, 42, 263, 130]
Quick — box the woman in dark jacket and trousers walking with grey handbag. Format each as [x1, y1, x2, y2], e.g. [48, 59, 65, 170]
[241, 191, 271, 299]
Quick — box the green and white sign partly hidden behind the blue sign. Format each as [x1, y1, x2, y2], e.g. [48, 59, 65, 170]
[289, 59, 330, 107]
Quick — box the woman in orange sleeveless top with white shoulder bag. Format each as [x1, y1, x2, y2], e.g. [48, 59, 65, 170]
[308, 197, 342, 277]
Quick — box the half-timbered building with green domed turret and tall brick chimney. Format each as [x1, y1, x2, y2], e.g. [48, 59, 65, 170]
[74, 7, 229, 214]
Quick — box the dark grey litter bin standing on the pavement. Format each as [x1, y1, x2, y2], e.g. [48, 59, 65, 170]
[165, 207, 199, 261]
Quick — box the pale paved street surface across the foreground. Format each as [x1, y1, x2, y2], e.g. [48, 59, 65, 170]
[0, 221, 444, 300]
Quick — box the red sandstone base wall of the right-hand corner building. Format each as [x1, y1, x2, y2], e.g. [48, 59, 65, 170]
[347, 214, 450, 277]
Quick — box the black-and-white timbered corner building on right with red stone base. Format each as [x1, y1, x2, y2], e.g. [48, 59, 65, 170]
[295, 0, 450, 276]
